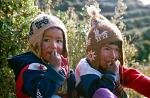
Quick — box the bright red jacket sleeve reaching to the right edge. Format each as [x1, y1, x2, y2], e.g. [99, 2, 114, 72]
[122, 67, 150, 98]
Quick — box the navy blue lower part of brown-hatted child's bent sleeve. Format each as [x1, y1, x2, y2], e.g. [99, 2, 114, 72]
[81, 73, 115, 98]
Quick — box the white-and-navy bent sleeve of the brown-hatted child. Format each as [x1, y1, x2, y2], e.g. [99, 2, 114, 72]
[75, 63, 117, 98]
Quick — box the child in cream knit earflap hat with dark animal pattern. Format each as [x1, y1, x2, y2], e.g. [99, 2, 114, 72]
[8, 13, 74, 98]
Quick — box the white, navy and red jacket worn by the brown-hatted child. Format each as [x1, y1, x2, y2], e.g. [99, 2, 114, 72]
[75, 58, 150, 98]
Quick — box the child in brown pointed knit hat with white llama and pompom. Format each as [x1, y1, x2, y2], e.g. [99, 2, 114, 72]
[75, 5, 150, 98]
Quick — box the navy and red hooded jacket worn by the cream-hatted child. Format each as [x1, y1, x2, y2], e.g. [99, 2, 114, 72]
[8, 52, 75, 98]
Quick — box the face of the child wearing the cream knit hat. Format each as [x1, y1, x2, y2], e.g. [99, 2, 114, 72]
[41, 28, 64, 63]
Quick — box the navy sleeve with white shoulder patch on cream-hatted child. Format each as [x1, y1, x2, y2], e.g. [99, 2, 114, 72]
[22, 64, 65, 98]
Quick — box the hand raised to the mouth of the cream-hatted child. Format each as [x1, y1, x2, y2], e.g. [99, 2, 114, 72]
[50, 51, 62, 70]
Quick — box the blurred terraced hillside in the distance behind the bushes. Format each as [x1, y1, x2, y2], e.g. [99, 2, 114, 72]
[55, 0, 150, 61]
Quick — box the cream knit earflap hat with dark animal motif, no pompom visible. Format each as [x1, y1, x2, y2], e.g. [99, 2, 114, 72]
[29, 13, 68, 58]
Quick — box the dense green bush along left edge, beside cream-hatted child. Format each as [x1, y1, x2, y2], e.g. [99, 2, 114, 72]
[0, 0, 38, 98]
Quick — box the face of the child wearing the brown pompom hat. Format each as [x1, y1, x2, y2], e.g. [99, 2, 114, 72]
[100, 44, 119, 70]
